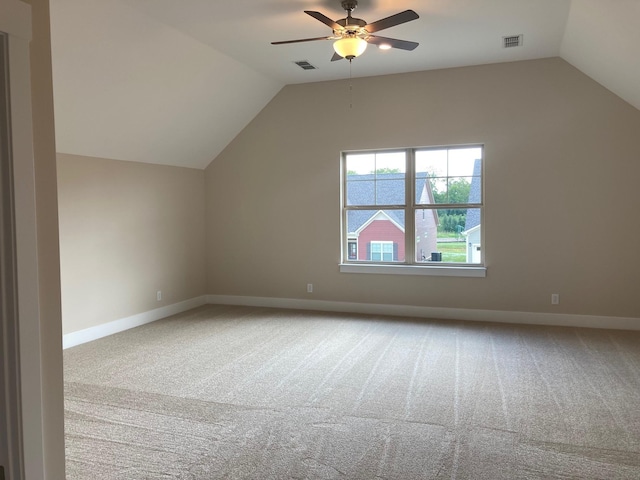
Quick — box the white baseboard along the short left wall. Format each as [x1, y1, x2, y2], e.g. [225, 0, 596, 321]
[62, 295, 207, 349]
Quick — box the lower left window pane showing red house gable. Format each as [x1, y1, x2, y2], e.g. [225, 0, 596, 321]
[347, 209, 405, 262]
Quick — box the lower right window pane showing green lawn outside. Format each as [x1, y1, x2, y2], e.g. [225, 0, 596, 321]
[415, 208, 482, 264]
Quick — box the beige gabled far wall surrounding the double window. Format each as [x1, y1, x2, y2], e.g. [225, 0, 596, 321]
[206, 58, 640, 317]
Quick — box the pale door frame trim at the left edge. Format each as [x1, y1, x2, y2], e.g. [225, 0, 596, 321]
[0, 0, 47, 480]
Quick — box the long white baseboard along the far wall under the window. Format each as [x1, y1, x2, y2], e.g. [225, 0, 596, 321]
[207, 295, 640, 330]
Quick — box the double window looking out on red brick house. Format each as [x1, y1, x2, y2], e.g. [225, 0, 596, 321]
[341, 145, 484, 276]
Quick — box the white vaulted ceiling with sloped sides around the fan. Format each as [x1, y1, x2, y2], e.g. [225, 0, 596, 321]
[51, 0, 640, 168]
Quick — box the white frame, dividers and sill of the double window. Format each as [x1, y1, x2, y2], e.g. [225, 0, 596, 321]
[339, 144, 487, 277]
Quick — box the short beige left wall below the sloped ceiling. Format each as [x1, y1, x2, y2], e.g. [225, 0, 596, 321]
[58, 154, 206, 334]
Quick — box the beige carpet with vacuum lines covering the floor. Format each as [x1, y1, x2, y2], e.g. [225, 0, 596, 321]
[64, 306, 640, 480]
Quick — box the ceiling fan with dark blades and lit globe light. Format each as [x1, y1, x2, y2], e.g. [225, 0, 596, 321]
[271, 0, 419, 62]
